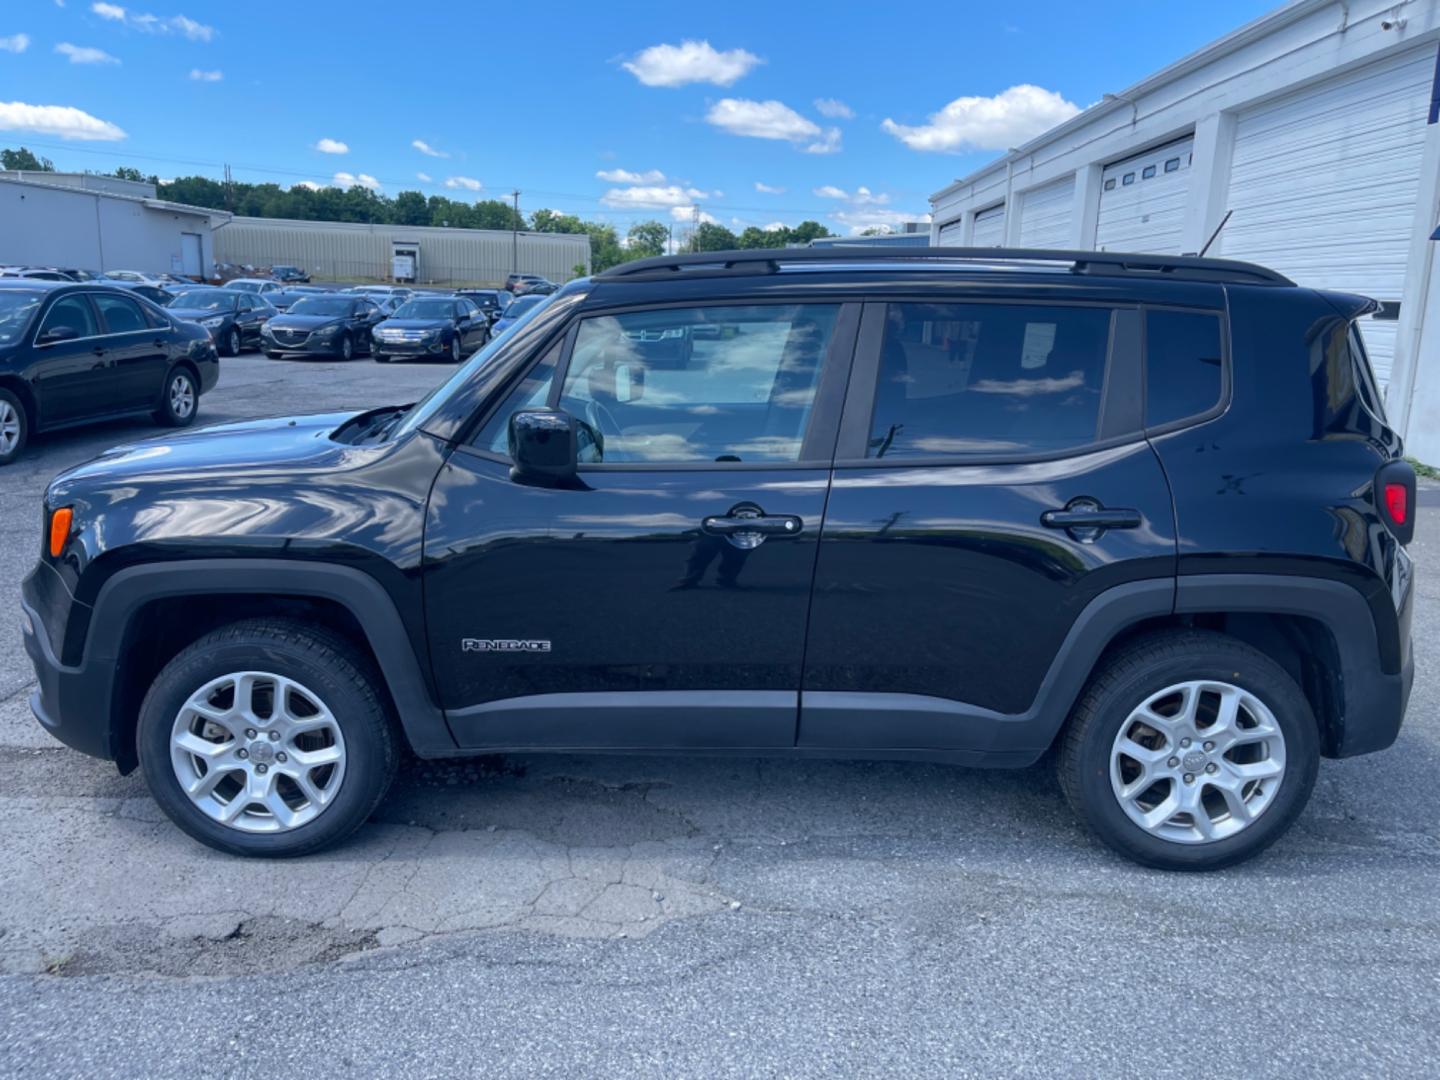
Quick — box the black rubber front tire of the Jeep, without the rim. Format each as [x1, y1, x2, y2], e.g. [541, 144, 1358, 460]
[137, 639, 387, 857]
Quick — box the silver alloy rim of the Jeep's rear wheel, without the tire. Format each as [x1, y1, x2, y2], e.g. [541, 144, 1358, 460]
[1110, 680, 1284, 844]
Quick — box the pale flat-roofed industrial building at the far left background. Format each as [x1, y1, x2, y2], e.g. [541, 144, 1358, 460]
[0, 171, 229, 278]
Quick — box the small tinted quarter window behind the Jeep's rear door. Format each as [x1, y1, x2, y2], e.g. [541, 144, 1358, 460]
[1145, 308, 1224, 428]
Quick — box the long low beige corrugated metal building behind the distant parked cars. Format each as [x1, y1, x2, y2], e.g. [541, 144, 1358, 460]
[215, 217, 590, 285]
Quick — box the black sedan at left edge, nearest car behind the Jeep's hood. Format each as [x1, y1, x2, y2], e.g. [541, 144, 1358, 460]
[0, 278, 220, 465]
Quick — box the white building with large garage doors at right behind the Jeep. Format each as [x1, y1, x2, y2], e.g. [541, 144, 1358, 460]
[930, 0, 1440, 462]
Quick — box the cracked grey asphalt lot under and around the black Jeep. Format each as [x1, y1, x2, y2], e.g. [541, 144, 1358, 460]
[0, 354, 1440, 1080]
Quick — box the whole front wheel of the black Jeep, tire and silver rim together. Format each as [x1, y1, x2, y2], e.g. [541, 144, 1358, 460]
[138, 619, 399, 858]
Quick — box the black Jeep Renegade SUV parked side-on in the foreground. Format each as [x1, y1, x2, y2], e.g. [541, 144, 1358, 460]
[24, 248, 1416, 868]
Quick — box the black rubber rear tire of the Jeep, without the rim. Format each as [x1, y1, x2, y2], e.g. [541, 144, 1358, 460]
[1076, 649, 1319, 870]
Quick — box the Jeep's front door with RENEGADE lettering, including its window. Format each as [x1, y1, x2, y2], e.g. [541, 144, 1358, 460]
[425, 302, 858, 749]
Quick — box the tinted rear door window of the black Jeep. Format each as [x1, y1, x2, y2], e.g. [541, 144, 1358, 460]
[865, 304, 1110, 458]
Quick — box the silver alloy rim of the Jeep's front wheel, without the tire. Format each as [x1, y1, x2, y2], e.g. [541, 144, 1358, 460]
[170, 671, 346, 832]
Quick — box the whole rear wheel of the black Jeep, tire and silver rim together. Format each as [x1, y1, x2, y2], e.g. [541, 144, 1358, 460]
[1060, 631, 1320, 870]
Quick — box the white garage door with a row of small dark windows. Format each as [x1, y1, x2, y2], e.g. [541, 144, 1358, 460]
[1094, 138, 1194, 255]
